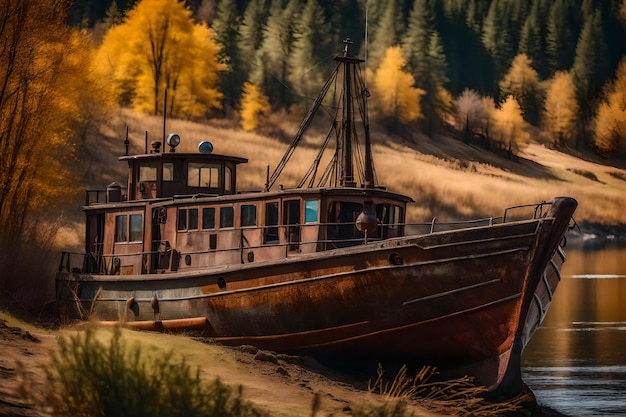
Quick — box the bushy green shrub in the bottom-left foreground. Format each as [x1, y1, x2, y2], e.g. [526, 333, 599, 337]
[32, 329, 265, 417]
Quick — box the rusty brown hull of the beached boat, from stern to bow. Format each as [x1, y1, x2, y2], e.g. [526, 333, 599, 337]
[57, 198, 576, 393]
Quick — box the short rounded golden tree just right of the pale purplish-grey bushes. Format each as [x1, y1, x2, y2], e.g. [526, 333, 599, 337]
[490, 96, 530, 157]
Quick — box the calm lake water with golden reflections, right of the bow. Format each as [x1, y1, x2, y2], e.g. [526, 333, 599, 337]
[523, 241, 626, 417]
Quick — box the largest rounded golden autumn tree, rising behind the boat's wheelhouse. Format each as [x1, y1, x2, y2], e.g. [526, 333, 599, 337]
[99, 0, 226, 117]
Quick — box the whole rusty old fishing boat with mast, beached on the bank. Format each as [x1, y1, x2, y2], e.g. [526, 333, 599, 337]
[56, 43, 577, 394]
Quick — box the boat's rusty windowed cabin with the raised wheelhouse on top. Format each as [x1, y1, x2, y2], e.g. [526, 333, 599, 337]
[74, 140, 412, 275]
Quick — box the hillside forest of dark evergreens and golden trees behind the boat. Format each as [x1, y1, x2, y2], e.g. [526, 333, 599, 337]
[62, 0, 626, 158]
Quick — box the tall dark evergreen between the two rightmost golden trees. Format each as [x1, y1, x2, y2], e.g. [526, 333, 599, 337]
[571, 10, 607, 148]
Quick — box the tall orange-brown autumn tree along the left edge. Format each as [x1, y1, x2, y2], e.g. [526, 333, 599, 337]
[0, 0, 111, 308]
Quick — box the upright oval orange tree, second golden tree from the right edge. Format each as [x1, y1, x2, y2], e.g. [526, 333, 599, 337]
[543, 71, 578, 147]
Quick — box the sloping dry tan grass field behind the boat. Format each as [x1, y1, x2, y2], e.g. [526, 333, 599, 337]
[59, 110, 626, 250]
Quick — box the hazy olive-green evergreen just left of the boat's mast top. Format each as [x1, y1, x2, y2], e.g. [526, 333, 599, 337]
[288, 0, 333, 101]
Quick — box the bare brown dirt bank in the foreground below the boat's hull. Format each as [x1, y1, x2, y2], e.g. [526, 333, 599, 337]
[0, 313, 569, 417]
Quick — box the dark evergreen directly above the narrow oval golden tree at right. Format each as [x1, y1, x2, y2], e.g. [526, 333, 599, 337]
[546, 0, 576, 74]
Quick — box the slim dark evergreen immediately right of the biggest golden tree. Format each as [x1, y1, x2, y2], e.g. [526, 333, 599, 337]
[211, 0, 247, 109]
